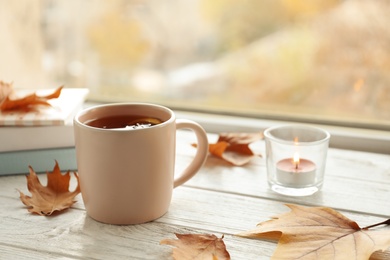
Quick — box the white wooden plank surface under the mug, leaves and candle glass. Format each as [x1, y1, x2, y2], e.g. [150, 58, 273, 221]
[0, 131, 390, 260]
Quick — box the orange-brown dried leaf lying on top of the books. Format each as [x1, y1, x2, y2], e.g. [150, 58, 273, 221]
[0, 86, 63, 111]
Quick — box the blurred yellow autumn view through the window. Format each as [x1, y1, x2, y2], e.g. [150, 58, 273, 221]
[0, 0, 390, 129]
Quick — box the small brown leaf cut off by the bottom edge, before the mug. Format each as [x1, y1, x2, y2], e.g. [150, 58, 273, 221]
[160, 234, 230, 260]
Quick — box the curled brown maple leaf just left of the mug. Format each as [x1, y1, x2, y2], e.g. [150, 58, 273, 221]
[19, 161, 80, 216]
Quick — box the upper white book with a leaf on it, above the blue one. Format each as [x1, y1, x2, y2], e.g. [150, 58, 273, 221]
[0, 88, 89, 152]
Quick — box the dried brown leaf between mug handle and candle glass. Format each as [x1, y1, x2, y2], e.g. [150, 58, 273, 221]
[194, 133, 263, 166]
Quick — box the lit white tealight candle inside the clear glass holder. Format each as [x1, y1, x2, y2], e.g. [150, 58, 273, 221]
[276, 153, 316, 187]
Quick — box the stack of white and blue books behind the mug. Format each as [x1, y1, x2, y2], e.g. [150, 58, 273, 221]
[0, 88, 88, 175]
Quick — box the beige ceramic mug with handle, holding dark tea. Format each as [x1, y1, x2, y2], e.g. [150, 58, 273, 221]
[74, 103, 208, 224]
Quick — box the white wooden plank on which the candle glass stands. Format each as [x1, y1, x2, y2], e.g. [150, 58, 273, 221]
[177, 133, 390, 216]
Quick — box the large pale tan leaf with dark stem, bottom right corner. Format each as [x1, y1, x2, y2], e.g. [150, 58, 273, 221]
[239, 204, 390, 260]
